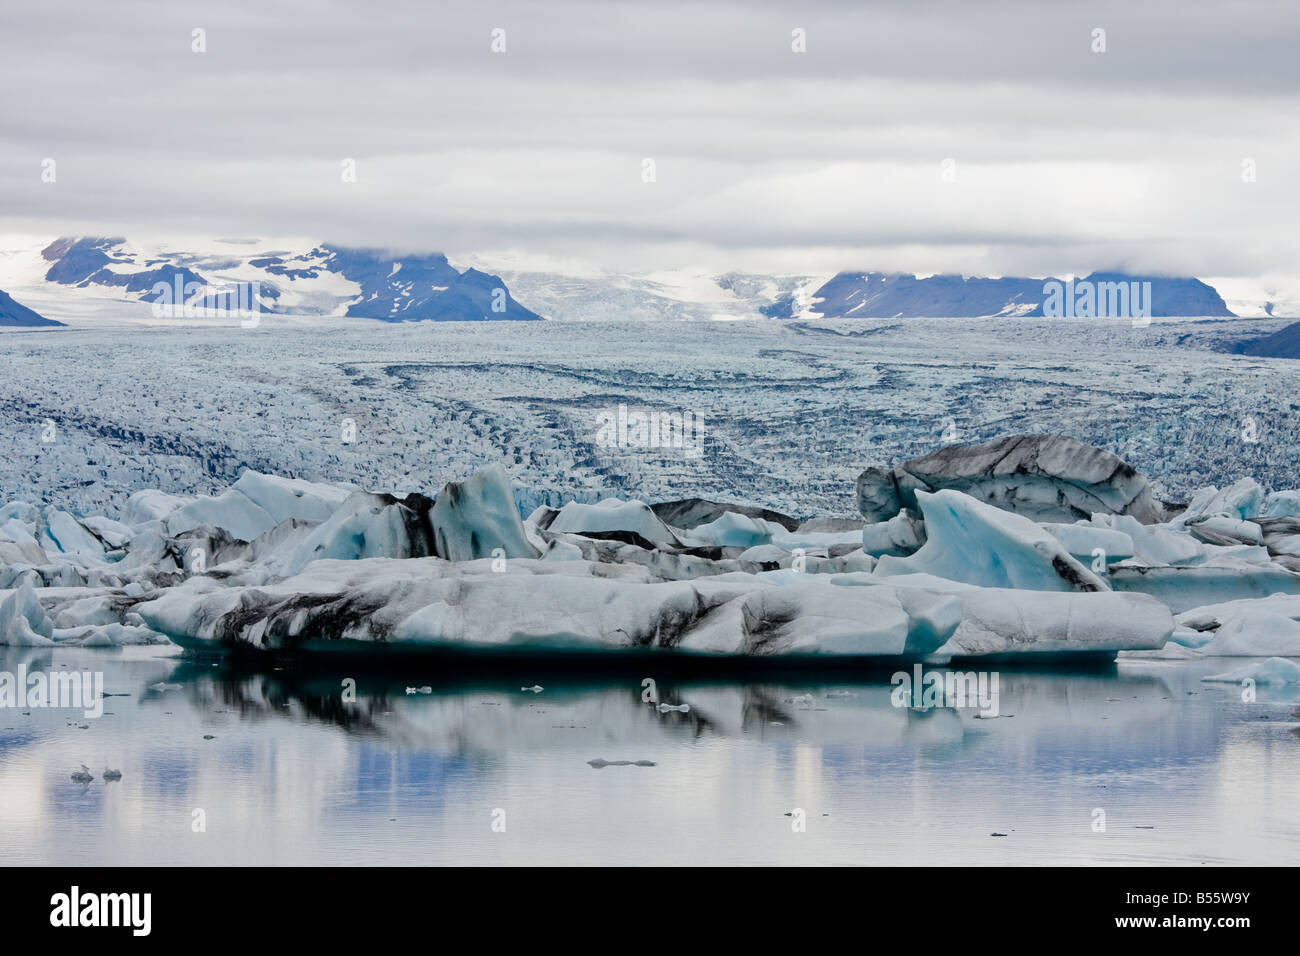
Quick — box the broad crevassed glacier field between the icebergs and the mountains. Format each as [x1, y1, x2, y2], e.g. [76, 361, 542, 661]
[0, 319, 1300, 516]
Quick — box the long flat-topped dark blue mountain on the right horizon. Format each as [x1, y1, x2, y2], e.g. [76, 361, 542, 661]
[810, 272, 1232, 319]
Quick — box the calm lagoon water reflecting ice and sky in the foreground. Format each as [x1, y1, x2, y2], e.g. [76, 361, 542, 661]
[0, 646, 1300, 865]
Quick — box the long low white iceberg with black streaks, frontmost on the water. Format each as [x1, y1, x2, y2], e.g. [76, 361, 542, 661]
[137, 558, 961, 657]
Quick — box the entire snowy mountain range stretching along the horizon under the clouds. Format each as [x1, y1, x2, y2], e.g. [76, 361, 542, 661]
[0, 237, 1268, 323]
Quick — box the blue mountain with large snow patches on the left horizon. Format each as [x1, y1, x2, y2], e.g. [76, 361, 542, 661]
[40, 237, 542, 323]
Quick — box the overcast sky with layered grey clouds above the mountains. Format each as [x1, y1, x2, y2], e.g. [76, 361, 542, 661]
[0, 0, 1300, 276]
